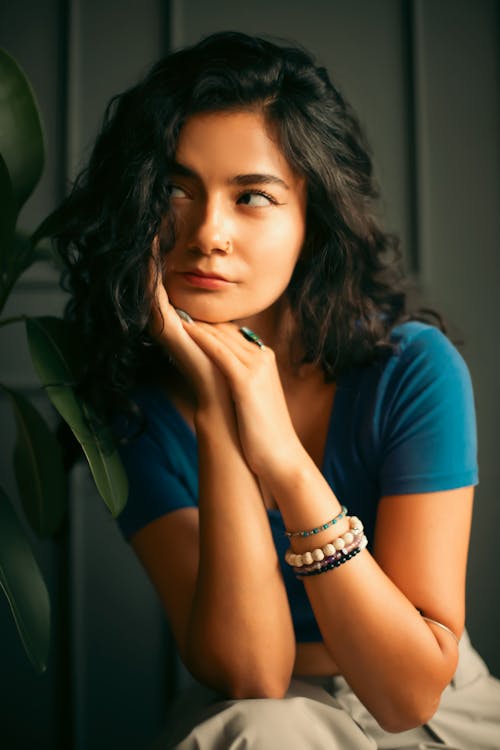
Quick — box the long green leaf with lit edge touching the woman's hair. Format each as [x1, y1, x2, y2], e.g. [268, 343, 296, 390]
[26, 317, 128, 516]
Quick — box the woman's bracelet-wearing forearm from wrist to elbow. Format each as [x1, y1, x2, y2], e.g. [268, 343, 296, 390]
[268, 457, 456, 731]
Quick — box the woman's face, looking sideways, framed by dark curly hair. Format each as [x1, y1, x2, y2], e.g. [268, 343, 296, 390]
[164, 112, 306, 323]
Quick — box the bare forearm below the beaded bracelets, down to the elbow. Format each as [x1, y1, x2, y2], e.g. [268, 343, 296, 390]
[305, 550, 456, 731]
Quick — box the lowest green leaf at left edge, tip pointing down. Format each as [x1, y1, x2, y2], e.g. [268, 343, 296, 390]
[0, 487, 50, 673]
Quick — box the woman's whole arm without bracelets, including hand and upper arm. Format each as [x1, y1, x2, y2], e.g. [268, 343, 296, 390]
[132, 274, 295, 698]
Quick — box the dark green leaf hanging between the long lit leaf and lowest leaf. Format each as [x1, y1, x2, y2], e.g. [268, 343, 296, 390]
[4, 388, 67, 537]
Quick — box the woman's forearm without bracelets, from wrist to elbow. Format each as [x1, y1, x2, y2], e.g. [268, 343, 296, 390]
[186, 407, 295, 697]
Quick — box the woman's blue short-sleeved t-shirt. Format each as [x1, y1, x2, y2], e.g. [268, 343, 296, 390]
[118, 321, 478, 642]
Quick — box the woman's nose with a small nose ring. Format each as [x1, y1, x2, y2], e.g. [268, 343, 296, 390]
[189, 196, 233, 255]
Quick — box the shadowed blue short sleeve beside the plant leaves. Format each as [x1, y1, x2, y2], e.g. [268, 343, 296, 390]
[117, 394, 198, 538]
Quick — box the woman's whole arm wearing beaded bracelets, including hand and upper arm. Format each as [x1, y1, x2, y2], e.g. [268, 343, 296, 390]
[186, 325, 472, 731]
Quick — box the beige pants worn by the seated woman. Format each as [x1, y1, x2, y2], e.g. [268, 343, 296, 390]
[152, 634, 500, 750]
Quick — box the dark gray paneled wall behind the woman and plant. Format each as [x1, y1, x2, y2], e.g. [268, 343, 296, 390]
[0, 0, 500, 750]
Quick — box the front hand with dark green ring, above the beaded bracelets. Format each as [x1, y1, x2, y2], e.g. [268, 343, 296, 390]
[183, 322, 304, 479]
